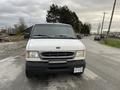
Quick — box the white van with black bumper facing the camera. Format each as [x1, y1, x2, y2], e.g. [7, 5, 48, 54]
[26, 24, 86, 78]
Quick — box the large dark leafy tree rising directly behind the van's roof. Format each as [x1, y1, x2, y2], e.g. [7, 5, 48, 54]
[46, 4, 88, 33]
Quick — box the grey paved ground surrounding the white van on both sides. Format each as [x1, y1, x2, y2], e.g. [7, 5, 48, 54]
[0, 37, 120, 90]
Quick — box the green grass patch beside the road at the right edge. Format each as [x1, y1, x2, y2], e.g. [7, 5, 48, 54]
[100, 38, 120, 48]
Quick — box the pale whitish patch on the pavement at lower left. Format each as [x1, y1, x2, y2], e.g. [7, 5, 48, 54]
[0, 56, 22, 88]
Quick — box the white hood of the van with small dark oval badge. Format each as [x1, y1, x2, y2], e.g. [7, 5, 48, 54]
[26, 39, 85, 51]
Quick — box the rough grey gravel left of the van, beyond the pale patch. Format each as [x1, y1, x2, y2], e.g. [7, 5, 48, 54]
[0, 40, 27, 60]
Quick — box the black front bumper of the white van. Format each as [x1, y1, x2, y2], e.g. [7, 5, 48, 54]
[26, 60, 86, 74]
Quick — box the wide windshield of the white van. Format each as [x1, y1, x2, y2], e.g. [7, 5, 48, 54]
[31, 24, 76, 39]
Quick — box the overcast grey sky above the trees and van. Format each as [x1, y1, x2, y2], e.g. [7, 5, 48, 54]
[0, 0, 120, 31]
